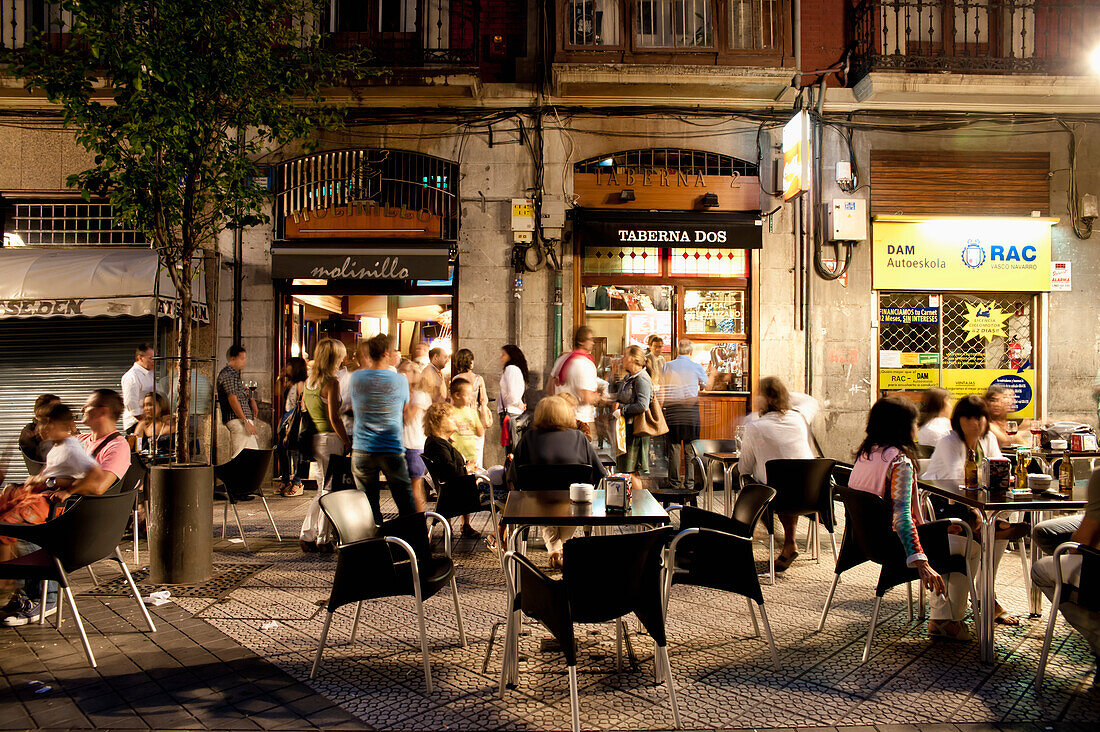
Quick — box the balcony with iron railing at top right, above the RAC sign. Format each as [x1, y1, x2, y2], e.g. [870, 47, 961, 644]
[851, 0, 1100, 78]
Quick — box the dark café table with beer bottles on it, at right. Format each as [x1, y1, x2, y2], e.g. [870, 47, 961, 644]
[920, 480, 1088, 663]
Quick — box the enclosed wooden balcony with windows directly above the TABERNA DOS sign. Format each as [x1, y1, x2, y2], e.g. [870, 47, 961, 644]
[556, 0, 793, 66]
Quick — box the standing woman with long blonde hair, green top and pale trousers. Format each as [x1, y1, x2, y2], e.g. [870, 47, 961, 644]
[298, 338, 351, 554]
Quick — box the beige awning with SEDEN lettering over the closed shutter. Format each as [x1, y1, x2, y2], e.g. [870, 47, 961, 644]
[0, 247, 209, 323]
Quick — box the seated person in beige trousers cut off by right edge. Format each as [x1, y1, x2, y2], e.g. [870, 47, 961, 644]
[1032, 470, 1100, 659]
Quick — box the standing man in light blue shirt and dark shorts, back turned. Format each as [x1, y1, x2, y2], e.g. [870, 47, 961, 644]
[661, 338, 706, 491]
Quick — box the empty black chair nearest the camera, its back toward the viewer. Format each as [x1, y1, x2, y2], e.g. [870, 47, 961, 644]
[501, 528, 680, 732]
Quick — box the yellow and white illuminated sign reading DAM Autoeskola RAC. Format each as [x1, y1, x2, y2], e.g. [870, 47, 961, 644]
[871, 216, 1058, 292]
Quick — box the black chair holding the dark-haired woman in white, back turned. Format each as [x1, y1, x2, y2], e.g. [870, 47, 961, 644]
[763, 458, 836, 584]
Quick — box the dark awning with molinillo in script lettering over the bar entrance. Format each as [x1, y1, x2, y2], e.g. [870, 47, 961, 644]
[272, 241, 450, 281]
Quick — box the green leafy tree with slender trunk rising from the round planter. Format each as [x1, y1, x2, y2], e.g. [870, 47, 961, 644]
[6, 0, 364, 462]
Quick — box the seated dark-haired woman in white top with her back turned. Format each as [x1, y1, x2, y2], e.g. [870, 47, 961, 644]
[737, 376, 814, 572]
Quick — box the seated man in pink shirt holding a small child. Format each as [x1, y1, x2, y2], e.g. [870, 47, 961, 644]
[0, 389, 130, 627]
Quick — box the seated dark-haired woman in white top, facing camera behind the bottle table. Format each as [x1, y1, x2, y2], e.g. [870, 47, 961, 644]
[921, 394, 1027, 625]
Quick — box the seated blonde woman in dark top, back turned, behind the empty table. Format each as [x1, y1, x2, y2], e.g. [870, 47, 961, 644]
[508, 396, 607, 569]
